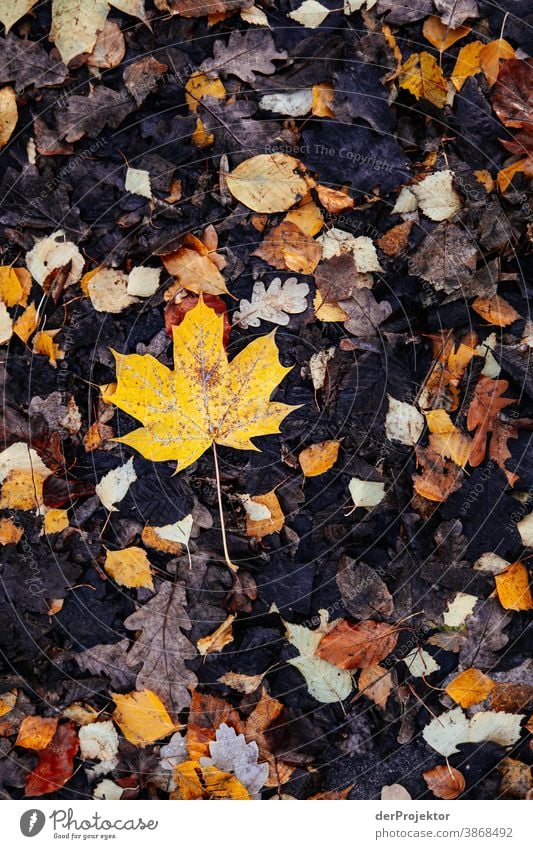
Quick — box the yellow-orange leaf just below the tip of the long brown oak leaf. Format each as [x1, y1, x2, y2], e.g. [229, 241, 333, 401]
[111, 690, 176, 746]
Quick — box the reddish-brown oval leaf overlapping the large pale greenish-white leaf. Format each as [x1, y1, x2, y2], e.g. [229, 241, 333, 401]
[316, 619, 398, 669]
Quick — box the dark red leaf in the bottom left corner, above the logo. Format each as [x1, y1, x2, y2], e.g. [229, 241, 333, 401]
[25, 722, 79, 796]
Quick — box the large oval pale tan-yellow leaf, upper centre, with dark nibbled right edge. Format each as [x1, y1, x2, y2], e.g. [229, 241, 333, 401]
[226, 153, 315, 212]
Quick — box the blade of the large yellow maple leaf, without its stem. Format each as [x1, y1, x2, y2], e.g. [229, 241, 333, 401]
[107, 298, 298, 471]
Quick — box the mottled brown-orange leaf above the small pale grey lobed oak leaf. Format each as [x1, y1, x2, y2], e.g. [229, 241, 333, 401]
[252, 221, 322, 274]
